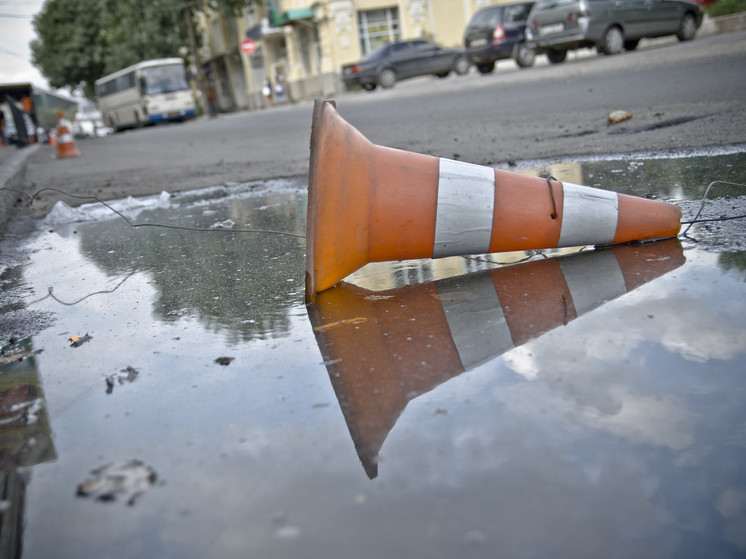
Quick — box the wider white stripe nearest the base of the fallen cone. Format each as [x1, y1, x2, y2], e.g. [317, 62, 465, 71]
[433, 158, 495, 258]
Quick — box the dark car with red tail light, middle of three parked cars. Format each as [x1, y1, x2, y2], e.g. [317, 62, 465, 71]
[464, 2, 535, 74]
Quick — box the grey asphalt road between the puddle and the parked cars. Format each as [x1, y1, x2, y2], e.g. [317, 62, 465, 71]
[20, 32, 746, 211]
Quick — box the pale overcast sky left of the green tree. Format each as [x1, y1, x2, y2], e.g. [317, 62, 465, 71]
[0, 0, 48, 88]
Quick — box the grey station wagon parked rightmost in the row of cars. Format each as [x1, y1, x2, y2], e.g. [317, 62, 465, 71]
[526, 0, 702, 64]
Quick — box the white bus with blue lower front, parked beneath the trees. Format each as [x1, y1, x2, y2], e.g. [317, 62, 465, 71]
[96, 58, 197, 130]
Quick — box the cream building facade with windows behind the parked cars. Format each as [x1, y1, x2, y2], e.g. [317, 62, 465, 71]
[199, 0, 507, 111]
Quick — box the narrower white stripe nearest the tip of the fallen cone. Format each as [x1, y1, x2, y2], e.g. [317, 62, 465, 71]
[557, 182, 619, 247]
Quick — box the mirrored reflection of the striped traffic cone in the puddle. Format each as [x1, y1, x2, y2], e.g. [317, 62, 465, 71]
[308, 239, 685, 478]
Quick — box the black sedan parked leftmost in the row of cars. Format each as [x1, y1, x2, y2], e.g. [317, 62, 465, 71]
[342, 39, 471, 91]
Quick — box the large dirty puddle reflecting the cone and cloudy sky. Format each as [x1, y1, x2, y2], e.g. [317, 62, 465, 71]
[0, 154, 746, 558]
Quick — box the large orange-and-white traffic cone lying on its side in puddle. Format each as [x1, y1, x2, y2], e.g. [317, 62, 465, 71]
[306, 100, 681, 301]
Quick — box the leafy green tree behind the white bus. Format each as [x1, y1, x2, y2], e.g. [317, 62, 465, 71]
[31, 0, 257, 97]
